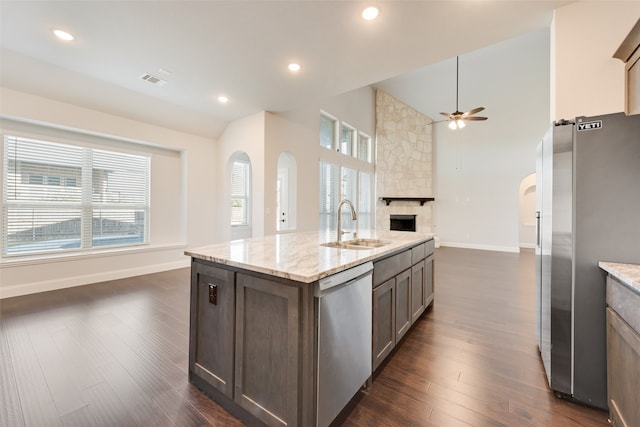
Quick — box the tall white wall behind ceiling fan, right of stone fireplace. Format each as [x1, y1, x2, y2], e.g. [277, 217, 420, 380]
[434, 31, 550, 252]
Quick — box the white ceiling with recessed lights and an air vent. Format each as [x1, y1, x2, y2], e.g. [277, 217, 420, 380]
[0, 0, 571, 138]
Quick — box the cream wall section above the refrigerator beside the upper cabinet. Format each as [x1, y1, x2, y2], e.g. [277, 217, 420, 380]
[550, 1, 640, 120]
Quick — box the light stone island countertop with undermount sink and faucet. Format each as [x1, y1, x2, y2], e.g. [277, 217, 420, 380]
[185, 231, 433, 283]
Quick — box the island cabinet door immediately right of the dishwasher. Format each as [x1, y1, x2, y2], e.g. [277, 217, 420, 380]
[372, 279, 396, 370]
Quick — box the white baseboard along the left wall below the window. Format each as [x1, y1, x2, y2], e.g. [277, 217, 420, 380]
[0, 257, 191, 299]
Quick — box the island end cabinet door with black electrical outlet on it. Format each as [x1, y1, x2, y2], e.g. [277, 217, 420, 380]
[189, 262, 235, 398]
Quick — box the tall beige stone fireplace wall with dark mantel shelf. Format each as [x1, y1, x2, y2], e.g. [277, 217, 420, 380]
[376, 90, 434, 233]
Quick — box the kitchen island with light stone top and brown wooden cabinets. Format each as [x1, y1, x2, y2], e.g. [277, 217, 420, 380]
[185, 232, 434, 426]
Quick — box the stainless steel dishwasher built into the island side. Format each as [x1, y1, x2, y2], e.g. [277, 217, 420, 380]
[314, 262, 373, 427]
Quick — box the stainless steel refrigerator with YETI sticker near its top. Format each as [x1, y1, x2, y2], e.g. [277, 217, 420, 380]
[536, 113, 640, 409]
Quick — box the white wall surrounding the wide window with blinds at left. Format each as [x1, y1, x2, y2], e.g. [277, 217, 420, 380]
[0, 88, 217, 297]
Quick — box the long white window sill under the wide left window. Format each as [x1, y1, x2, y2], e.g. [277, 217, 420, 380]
[0, 243, 187, 268]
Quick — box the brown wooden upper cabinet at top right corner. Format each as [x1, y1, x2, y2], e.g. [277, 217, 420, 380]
[613, 19, 640, 114]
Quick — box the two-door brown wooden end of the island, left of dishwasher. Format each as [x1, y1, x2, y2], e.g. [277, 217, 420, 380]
[189, 260, 313, 426]
